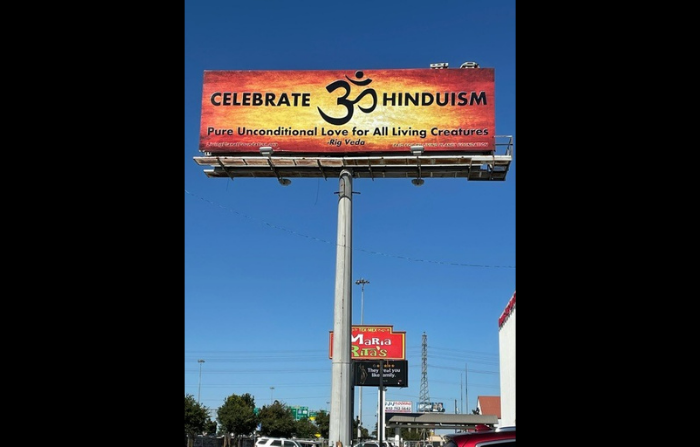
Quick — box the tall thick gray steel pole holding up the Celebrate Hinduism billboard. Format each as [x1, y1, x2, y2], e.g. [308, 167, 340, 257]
[328, 169, 352, 447]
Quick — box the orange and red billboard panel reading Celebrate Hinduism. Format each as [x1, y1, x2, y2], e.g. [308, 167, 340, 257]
[199, 68, 496, 155]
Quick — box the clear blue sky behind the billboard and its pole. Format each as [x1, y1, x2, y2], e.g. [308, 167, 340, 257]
[183, 0, 517, 431]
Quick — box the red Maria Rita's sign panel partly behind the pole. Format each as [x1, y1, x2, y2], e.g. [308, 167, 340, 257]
[328, 326, 406, 360]
